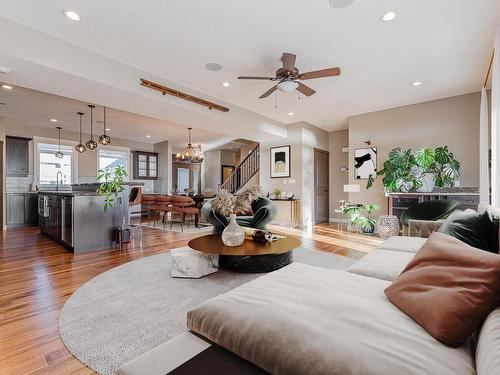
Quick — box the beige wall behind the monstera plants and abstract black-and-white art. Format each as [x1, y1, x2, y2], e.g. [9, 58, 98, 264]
[349, 93, 480, 215]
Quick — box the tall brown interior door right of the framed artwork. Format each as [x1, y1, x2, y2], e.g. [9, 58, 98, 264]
[314, 149, 330, 224]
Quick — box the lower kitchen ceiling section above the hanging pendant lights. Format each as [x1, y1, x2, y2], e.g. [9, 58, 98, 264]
[0, 87, 227, 149]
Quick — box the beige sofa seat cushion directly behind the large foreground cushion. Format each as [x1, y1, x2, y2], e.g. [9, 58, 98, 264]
[347, 249, 415, 281]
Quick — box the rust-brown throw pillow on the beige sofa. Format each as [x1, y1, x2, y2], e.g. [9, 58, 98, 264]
[385, 233, 500, 346]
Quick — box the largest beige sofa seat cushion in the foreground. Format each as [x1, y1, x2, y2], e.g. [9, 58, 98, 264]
[188, 263, 475, 375]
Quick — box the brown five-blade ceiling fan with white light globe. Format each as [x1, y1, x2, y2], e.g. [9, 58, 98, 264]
[238, 52, 340, 99]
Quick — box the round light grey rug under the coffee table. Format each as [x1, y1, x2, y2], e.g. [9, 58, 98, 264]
[59, 249, 355, 374]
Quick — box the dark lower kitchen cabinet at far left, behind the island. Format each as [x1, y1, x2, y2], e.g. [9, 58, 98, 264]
[7, 193, 38, 228]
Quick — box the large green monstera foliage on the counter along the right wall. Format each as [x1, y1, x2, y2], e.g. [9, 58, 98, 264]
[366, 146, 460, 193]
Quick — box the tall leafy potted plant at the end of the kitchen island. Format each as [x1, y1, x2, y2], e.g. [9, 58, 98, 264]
[97, 165, 130, 242]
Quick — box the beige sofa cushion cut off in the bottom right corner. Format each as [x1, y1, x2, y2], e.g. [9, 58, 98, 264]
[476, 307, 500, 375]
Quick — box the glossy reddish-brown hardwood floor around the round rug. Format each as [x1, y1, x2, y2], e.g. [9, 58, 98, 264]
[0, 224, 380, 375]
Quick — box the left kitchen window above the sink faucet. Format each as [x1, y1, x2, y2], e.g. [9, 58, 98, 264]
[37, 143, 74, 185]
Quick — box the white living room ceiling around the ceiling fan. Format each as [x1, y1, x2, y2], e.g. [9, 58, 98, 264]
[0, 0, 500, 130]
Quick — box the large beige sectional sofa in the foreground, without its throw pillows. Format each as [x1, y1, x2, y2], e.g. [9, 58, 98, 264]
[119, 237, 500, 375]
